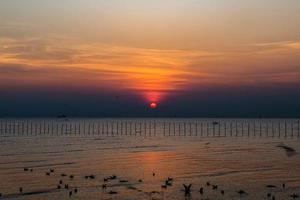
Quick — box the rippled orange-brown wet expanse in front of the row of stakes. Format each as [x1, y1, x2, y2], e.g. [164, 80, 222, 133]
[0, 119, 300, 200]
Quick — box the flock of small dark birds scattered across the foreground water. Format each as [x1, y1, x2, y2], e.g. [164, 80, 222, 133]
[0, 168, 300, 200]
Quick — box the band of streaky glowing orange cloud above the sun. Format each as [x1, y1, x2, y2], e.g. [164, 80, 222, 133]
[0, 36, 300, 98]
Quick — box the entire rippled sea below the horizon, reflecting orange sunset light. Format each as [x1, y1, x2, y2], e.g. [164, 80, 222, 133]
[0, 119, 300, 200]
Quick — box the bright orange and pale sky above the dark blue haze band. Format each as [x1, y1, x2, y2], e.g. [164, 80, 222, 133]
[0, 0, 300, 101]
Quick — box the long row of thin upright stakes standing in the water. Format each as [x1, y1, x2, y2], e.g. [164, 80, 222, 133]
[0, 120, 300, 137]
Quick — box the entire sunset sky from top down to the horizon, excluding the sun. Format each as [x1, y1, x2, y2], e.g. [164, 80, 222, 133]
[0, 0, 300, 117]
